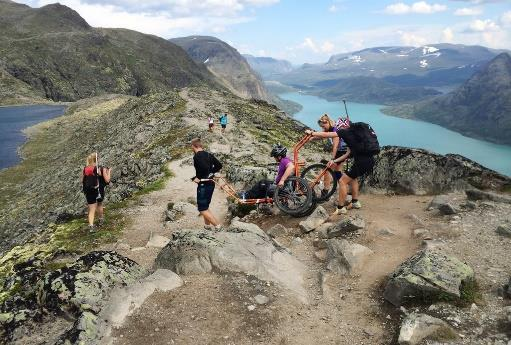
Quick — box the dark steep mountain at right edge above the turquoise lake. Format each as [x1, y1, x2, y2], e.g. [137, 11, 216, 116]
[386, 53, 511, 145]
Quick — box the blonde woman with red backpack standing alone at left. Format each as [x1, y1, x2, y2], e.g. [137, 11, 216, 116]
[82, 153, 112, 231]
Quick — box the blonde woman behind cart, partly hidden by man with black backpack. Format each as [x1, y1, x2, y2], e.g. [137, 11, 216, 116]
[318, 114, 349, 195]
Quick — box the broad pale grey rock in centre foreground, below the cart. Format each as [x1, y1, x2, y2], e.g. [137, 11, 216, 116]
[155, 221, 306, 301]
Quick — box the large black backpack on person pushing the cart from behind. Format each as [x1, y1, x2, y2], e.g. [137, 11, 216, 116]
[337, 122, 380, 155]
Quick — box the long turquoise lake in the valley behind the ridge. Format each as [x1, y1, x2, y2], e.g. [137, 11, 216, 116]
[279, 92, 511, 176]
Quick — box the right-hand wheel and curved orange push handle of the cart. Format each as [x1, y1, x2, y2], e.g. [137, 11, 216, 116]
[293, 134, 337, 203]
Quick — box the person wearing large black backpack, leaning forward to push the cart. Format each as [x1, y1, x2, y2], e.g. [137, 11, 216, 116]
[305, 122, 380, 215]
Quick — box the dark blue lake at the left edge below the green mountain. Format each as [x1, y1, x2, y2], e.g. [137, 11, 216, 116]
[0, 105, 66, 169]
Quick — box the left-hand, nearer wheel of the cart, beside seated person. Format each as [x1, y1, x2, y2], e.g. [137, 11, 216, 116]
[273, 176, 314, 216]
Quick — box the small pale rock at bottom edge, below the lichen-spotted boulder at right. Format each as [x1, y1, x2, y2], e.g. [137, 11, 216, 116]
[398, 313, 456, 345]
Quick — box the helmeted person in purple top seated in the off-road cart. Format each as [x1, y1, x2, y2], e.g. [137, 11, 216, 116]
[240, 144, 295, 199]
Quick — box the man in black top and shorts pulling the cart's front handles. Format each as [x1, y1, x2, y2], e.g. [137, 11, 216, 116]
[191, 138, 222, 227]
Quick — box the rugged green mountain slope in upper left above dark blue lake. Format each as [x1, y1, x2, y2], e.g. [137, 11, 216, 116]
[0, 0, 218, 101]
